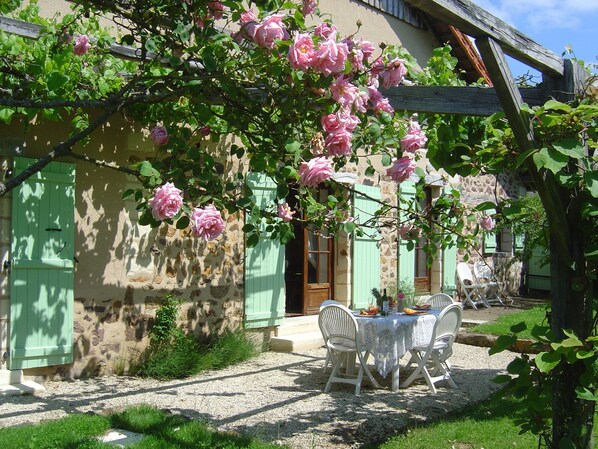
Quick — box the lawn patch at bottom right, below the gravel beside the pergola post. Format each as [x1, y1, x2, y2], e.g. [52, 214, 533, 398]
[379, 397, 538, 449]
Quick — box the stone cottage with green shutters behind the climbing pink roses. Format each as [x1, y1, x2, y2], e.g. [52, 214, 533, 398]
[0, 0, 524, 378]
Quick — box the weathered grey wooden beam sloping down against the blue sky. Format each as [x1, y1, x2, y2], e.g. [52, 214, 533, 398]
[405, 0, 564, 76]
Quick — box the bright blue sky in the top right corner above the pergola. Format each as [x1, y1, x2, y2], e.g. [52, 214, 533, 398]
[473, 0, 598, 76]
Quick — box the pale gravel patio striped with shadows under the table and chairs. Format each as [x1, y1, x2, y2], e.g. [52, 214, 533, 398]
[0, 344, 513, 449]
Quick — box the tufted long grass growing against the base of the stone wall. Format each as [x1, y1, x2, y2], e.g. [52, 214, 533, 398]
[131, 330, 258, 380]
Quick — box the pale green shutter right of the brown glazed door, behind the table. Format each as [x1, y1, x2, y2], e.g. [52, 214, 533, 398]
[351, 185, 381, 309]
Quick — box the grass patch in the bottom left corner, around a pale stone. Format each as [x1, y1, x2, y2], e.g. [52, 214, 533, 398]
[0, 405, 281, 449]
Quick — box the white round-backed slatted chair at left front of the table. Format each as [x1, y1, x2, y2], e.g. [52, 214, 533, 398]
[318, 304, 380, 396]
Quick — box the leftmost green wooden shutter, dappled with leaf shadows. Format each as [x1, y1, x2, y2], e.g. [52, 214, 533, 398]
[9, 158, 75, 369]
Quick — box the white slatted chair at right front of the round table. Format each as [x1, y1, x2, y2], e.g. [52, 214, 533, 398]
[401, 303, 463, 393]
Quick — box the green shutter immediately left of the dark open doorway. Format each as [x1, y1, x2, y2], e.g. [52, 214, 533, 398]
[245, 173, 285, 328]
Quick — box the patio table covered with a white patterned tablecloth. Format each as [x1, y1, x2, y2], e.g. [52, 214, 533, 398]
[356, 309, 440, 391]
